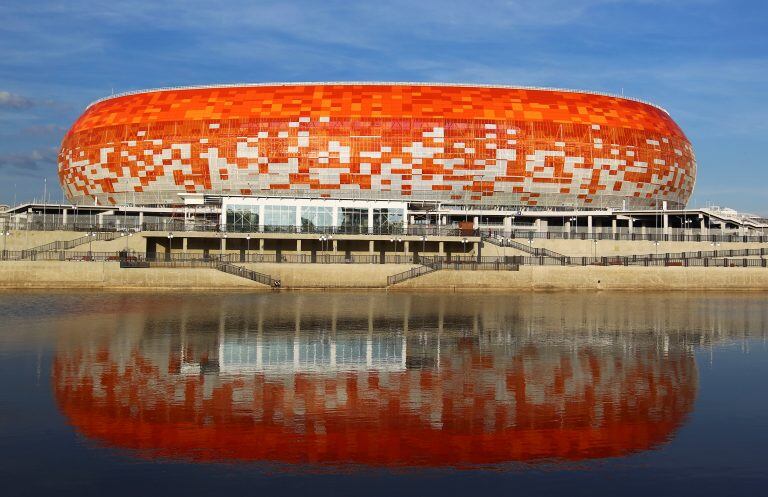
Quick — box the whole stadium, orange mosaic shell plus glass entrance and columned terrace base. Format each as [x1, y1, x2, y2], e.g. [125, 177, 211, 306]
[3, 82, 768, 274]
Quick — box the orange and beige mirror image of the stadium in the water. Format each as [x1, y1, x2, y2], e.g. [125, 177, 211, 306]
[53, 294, 698, 469]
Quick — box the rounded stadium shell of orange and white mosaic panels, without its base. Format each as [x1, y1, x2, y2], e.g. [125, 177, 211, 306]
[59, 83, 696, 208]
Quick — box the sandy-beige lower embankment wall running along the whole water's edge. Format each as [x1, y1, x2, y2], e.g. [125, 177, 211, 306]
[0, 261, 768, 292]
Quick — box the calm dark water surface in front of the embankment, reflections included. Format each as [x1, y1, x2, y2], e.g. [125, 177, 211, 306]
[0, 292, 768, 496]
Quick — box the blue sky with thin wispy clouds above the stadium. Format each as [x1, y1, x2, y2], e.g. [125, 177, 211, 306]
[0, 0, 768, 214]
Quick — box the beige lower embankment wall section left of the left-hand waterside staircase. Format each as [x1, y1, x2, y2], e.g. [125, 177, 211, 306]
[0, 261, 269, 290]
